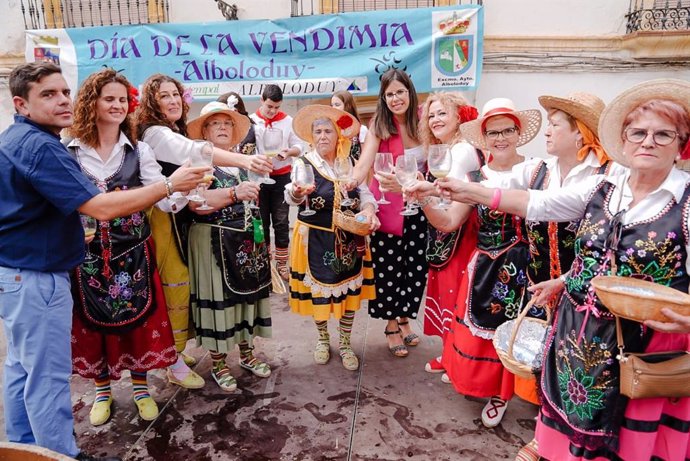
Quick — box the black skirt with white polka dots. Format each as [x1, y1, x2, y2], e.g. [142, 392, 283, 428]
[369, 213, 428, 320]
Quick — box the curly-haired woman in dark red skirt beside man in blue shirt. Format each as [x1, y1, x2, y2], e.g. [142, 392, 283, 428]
[67, 69, 203, 426]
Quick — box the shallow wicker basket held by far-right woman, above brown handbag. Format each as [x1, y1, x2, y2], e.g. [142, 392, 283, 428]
[592, 275, 690, 322]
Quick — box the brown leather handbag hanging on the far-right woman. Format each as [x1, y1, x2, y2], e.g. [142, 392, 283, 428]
[616, 317, 690, 399]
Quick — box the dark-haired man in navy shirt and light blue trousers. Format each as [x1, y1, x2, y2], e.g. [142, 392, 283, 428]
[0, 62, 206, 459]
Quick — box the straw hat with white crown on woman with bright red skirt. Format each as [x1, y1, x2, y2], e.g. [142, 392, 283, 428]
[460, 98, 541, 149]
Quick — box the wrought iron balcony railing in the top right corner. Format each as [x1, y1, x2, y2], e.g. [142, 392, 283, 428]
[625, 0, 690, 34]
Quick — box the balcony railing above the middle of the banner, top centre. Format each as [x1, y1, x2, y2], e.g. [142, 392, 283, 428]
[291, 0, 483, 16]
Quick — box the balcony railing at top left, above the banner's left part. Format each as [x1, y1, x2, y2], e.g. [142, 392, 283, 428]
[21, 0, 170, 29]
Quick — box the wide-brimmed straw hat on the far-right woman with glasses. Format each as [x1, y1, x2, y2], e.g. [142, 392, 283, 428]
[599, 78, 690, 166]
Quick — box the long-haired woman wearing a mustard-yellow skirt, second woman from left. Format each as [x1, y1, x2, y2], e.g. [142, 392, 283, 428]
[136, 74, 272, 389]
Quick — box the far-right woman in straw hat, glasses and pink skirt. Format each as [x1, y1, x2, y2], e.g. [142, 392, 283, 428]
[439, 79, 690, 460]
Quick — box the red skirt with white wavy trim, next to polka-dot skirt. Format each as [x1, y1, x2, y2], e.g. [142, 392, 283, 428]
[424, 212, 477, 341]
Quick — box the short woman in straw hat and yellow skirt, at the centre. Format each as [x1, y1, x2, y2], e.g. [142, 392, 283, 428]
[285, 105, 379, 370]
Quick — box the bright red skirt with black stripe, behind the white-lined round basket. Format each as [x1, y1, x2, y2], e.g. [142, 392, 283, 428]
[441, 252, 515, 400]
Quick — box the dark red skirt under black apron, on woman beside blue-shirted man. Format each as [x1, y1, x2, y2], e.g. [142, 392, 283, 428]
[72, 241, 177, 379]
